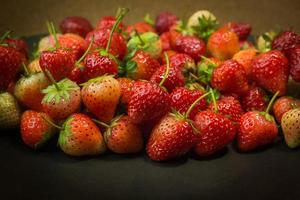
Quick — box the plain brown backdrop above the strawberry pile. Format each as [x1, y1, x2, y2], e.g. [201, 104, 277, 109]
[0, 0, 300, 36]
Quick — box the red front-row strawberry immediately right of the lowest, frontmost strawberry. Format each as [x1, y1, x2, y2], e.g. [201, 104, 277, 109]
[194, 111, 236, 156]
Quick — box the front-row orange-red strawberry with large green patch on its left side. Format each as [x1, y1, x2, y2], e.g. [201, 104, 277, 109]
[58, 113, 106, 156]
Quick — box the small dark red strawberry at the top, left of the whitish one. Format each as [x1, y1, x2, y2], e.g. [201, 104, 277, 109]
[155, 12, 177, 34]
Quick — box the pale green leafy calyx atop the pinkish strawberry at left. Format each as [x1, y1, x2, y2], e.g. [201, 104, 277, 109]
[42, 78, 80, 103]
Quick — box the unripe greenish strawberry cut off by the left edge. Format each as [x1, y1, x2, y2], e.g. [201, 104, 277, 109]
[0, 92, 21, 130]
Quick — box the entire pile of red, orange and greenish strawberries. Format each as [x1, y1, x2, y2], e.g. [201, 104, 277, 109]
[0, 8, 300, 161]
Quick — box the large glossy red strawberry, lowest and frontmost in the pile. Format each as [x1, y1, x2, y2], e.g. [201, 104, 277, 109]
[146, 114, 199, 161]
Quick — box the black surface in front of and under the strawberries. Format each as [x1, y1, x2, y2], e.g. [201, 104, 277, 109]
[0, 35, 300, 200]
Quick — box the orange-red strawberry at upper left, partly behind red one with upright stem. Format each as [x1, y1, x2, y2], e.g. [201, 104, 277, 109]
[58, 33, 88, 60]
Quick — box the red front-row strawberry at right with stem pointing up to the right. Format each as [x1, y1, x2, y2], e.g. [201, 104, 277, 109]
[237, 111, 278, 151]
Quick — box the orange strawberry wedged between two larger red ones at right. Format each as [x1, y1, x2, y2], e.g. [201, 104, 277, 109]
[232, 48, 257, 80]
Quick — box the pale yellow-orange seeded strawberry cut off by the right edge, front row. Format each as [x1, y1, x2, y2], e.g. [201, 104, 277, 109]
[281, 108, 300, 148]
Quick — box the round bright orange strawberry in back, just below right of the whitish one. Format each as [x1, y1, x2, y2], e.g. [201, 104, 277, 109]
[207, 28, 240, 60]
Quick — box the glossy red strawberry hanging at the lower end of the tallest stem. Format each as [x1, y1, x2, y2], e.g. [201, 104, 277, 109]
[83, 51, 118, 81]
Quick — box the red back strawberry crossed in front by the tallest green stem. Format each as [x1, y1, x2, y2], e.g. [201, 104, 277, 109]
[85, 28, 127, 60]
